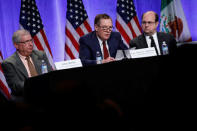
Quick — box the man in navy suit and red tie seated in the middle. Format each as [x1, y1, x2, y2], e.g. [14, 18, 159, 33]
[79, 14, 127, 65]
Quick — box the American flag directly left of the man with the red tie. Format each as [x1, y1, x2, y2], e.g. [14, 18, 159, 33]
[64, 0, 92, 60]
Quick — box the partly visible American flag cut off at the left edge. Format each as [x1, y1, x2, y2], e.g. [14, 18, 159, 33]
[0, 51, 11, 100]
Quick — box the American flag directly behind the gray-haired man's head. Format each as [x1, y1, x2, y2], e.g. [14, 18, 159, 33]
[20, 0, 54, 68]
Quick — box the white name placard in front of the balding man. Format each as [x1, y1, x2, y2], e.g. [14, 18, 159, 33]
[130, 47, 157, 58]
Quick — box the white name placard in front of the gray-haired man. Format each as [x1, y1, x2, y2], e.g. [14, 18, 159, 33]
[55, 59, 82, 70]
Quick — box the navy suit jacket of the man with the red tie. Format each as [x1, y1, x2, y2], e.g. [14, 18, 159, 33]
[79, 31, 128, 65]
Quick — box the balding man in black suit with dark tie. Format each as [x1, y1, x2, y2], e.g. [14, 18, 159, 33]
[130, 11, 177, 55]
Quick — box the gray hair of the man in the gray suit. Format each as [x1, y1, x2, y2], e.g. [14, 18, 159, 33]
[12, 29, 31, 43]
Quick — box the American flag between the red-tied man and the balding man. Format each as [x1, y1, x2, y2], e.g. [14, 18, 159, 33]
[116, 0, 142, 47]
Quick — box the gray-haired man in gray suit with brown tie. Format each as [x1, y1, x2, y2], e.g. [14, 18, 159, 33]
[2, 29, 52, 101]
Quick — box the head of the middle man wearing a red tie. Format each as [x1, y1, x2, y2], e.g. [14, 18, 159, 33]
[94, 14, 113, 41]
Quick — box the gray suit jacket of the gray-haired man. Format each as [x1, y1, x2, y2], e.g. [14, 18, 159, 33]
[2, 50, 52, 101]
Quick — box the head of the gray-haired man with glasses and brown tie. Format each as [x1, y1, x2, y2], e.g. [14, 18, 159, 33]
[12, 29, 33, 56]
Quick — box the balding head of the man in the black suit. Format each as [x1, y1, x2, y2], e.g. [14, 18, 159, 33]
[142, 11, 159, 35]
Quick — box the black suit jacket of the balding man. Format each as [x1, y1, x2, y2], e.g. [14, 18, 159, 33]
[130, 32, 177, 55]
